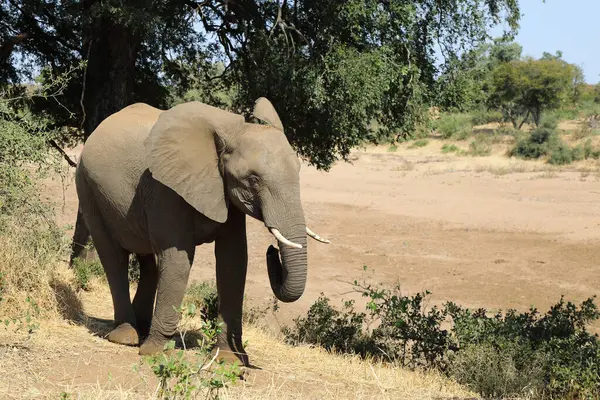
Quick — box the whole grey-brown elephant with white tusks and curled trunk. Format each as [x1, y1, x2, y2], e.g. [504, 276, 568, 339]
[75, 97, 329, 366]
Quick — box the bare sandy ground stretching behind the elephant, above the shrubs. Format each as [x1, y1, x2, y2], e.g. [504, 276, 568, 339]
[48, 141, 600, 330]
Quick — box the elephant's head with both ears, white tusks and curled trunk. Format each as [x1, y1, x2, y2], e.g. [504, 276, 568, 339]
[145, 98, 328, 302]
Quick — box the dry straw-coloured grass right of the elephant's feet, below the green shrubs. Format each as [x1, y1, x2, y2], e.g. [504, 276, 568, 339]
[224, 327, 475, 400]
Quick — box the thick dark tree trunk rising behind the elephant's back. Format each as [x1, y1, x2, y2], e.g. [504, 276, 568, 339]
[70, 5, 141, 266]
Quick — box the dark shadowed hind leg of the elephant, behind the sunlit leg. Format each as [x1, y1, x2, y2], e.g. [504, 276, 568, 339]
[133, 254, 158, 342]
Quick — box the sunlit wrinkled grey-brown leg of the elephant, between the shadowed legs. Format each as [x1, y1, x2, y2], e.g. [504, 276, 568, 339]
[139, 244, 195, 355]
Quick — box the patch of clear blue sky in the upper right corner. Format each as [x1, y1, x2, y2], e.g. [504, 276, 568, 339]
[493, 0, 600, 83]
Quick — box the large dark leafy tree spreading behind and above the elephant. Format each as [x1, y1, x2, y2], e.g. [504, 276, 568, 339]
[0, 0, 520, 260]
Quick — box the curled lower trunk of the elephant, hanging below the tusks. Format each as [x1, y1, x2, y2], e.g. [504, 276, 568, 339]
[267, 220, 307, 303]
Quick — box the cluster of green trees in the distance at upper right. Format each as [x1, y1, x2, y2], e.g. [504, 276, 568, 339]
[437, 38, 591, 129]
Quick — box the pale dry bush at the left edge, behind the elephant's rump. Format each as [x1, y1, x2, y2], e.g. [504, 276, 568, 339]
[0, 76, 72, 324]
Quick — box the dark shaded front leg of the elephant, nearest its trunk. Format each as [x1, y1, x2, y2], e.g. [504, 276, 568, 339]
[215, 207, 249, 366]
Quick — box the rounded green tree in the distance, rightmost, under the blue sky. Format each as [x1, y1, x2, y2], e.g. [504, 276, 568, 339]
[491, 57, 578, 129]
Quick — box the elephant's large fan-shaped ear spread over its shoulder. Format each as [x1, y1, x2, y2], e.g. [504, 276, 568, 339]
[144, 102, 244, 223]
